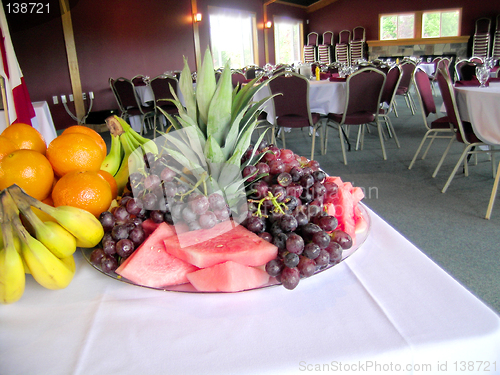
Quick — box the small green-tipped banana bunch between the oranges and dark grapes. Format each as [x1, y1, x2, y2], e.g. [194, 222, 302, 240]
[101, 115, 158, 195]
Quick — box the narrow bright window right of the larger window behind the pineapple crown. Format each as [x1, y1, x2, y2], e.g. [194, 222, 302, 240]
[274, 17, 303, 64]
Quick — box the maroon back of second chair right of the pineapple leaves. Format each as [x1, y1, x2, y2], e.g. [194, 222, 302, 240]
[342, 68, 386, 124]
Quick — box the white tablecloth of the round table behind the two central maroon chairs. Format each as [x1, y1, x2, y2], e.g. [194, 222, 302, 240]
[254, 80, 346, 124]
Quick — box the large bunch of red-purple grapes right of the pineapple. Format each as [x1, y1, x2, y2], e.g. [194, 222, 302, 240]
[243, 142, 352, 289]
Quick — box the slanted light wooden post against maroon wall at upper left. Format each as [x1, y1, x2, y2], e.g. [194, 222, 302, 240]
[59, 0, 85, 123]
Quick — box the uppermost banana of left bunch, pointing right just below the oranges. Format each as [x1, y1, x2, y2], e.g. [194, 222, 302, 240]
[8, 185, 104, 247]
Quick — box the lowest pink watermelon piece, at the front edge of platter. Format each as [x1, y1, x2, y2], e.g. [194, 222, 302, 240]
[187, 261, 269, 292]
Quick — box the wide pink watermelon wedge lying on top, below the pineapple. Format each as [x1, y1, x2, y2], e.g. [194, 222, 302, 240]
[165, 220, 278, 268]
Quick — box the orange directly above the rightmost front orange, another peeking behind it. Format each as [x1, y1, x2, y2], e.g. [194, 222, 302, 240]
[47, 133, 104, 177]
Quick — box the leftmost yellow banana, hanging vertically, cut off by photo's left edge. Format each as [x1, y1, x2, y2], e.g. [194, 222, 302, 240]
[0, 194, 26, 304]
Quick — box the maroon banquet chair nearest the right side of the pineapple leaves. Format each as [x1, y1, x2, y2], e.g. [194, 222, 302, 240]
[268, 72, 323, 160]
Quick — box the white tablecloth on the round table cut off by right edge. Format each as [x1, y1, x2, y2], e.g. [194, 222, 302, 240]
[456, 82, 500, 145]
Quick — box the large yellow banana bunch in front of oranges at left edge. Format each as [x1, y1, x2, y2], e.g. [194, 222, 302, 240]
[0, 185, 104, 304]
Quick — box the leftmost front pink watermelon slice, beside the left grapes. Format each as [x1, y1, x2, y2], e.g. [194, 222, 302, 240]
[115, 223, 198, 288]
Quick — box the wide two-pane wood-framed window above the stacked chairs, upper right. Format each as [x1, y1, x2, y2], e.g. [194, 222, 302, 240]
[379, 9, 461, 40]
